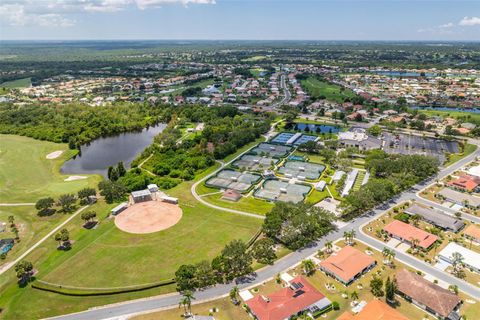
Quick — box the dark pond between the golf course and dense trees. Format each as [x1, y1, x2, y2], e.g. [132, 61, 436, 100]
[60, 123, 166, 176]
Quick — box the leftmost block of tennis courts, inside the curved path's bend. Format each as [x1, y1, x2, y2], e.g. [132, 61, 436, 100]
[205, 169, 262, 192]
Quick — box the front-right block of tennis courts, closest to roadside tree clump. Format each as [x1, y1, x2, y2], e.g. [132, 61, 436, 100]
[254, 180, 312, 203]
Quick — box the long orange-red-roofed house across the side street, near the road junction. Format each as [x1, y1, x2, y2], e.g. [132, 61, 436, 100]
[383, 220, 438, 250]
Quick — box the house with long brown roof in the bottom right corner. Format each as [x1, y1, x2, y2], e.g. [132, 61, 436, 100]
[396, 269, 461, 319]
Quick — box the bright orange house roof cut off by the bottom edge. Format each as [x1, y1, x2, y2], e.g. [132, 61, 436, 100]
[337, 300, 408, 320]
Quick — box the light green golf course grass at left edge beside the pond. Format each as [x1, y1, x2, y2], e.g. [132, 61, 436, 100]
[0, 135, 100, 203]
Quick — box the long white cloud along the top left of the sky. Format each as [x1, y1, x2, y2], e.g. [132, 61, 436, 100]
[0, 0, 215, 27]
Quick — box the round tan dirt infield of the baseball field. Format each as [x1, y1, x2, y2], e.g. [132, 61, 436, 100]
[115, 201, 182, 234]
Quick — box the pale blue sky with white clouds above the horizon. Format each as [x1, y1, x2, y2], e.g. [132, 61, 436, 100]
[0, 0, 480, 41]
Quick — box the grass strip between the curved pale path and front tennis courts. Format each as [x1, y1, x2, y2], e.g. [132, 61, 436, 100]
[203, 193, 274, 215]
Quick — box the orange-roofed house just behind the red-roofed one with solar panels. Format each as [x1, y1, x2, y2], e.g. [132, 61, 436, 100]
[320, 246, 377, 286]
